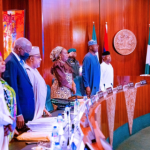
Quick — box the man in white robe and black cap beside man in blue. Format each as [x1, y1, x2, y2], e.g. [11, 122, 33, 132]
[100, 51, 114, 91]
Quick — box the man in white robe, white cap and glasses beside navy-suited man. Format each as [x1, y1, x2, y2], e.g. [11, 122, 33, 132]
[25, 46, 51, 120]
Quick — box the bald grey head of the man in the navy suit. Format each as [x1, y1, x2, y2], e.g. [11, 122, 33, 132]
[14, 37, 32, 56]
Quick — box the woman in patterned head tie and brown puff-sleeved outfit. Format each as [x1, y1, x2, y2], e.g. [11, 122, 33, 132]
[50, 46, 76, 99]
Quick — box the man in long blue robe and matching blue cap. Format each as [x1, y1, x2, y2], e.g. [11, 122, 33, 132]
[82, 40, 100, 96]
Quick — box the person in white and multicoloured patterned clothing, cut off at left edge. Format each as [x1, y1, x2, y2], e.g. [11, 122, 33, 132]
[0, 53, 16, 150]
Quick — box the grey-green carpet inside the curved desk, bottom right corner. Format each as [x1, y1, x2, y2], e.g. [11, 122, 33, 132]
[116, 127, 150, 150]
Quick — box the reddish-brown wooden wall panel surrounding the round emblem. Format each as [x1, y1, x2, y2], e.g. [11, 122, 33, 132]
[100, 0, 149, 76]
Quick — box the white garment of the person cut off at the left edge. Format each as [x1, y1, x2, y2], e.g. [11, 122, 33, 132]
[0, 82, 13, 150]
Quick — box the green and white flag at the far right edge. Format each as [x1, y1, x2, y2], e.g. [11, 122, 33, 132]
[145, 27, 150, 74]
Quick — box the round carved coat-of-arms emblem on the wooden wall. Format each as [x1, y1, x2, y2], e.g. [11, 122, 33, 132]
[114, 29, 137, 55]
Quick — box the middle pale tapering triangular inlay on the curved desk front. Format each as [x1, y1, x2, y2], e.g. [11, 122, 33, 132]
[106, 94, 116, 145]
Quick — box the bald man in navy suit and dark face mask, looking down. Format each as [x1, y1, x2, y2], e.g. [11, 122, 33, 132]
[3, 38, 35, 129]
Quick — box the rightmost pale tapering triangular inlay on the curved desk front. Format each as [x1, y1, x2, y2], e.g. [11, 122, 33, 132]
[124, 88, 137, 134]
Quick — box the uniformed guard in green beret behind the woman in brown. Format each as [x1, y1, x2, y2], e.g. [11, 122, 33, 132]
[67, 48, 80, 78]
